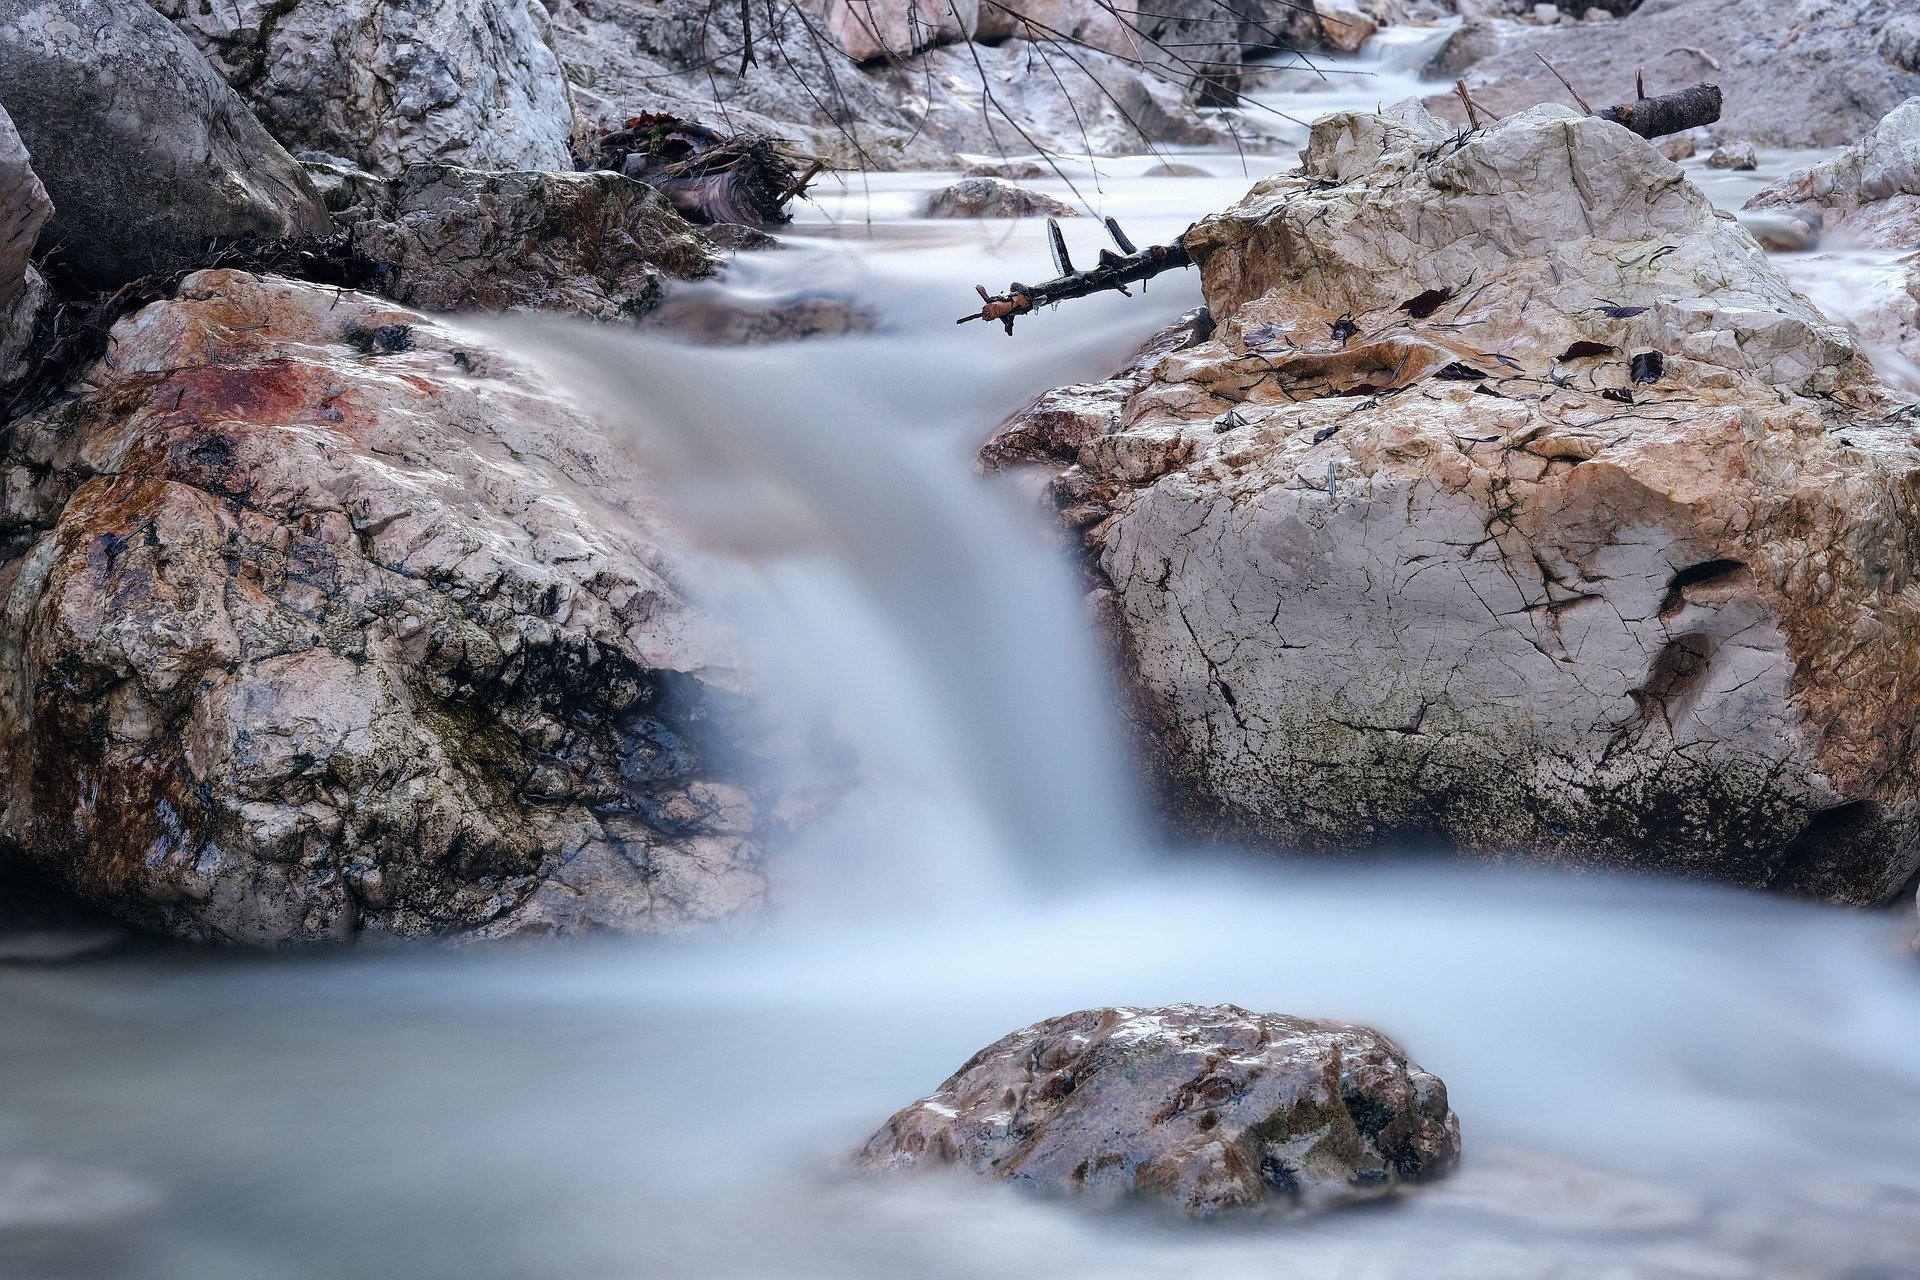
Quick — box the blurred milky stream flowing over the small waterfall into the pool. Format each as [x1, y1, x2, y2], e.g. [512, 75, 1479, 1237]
[0, 22, 1920, 1280]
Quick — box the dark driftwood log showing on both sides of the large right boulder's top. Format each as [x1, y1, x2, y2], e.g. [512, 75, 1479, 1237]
[954, 80, 1720, 334]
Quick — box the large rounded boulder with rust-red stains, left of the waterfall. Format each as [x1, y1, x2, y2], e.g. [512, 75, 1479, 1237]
[0, 271, 772, 944]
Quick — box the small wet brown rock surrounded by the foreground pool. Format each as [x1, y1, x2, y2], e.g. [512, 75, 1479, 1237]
[856, 1004, 1459, 1217]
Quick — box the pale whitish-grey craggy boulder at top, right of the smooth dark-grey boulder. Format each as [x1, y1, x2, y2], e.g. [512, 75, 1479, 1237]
[150, 0, 574, 175]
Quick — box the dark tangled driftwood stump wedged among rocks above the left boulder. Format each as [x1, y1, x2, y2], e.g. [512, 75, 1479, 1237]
[597, 113, 822, 226]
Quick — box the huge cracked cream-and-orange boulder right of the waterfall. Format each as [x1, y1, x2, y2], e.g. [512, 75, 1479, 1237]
[1016, 106, 1920, 902]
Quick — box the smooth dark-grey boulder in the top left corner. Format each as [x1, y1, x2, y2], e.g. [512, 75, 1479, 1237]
[0, 0, 328, 290]
